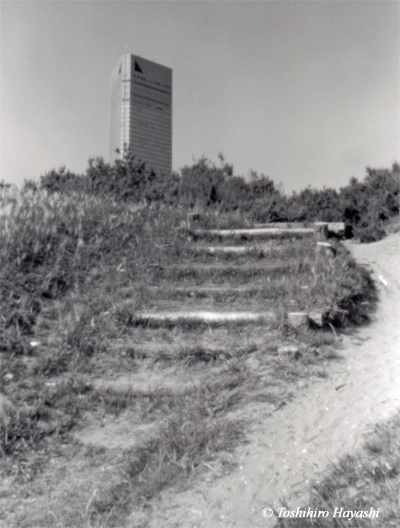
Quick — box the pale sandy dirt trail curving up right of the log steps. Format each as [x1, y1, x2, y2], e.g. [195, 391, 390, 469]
[145, 233, 400, 528]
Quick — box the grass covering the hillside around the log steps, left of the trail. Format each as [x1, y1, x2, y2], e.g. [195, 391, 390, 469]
[0, 189, 375, 528]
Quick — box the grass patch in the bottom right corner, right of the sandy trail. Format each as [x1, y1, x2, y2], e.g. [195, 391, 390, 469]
[279, 413, 400, 528]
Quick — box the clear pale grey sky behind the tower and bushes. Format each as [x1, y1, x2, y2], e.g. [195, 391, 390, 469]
[0, 0, 400, 193]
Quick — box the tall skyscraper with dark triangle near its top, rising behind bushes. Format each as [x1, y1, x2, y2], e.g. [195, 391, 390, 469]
[110, 54, 172, 173]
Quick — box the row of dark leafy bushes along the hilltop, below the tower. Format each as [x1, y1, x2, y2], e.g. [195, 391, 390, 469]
[35, 152, 400, 242]
